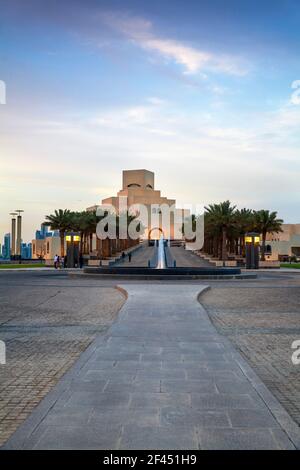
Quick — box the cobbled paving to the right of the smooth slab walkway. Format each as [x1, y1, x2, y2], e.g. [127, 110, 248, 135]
[201, 281, 300, 425]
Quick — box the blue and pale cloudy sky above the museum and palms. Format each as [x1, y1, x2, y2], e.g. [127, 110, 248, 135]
[0, 0, 300, 242]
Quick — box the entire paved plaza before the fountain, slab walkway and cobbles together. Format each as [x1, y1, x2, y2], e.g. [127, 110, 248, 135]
[0, 253, 300, 449]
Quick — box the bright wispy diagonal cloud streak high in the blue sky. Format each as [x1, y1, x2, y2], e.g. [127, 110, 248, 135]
[101, 13, 247, 76]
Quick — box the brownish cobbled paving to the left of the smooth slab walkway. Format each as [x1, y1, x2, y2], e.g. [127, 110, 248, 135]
[0, 280, 124, 445]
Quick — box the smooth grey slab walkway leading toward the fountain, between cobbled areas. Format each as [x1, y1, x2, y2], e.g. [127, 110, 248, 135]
[5, 283, 300, 449]
